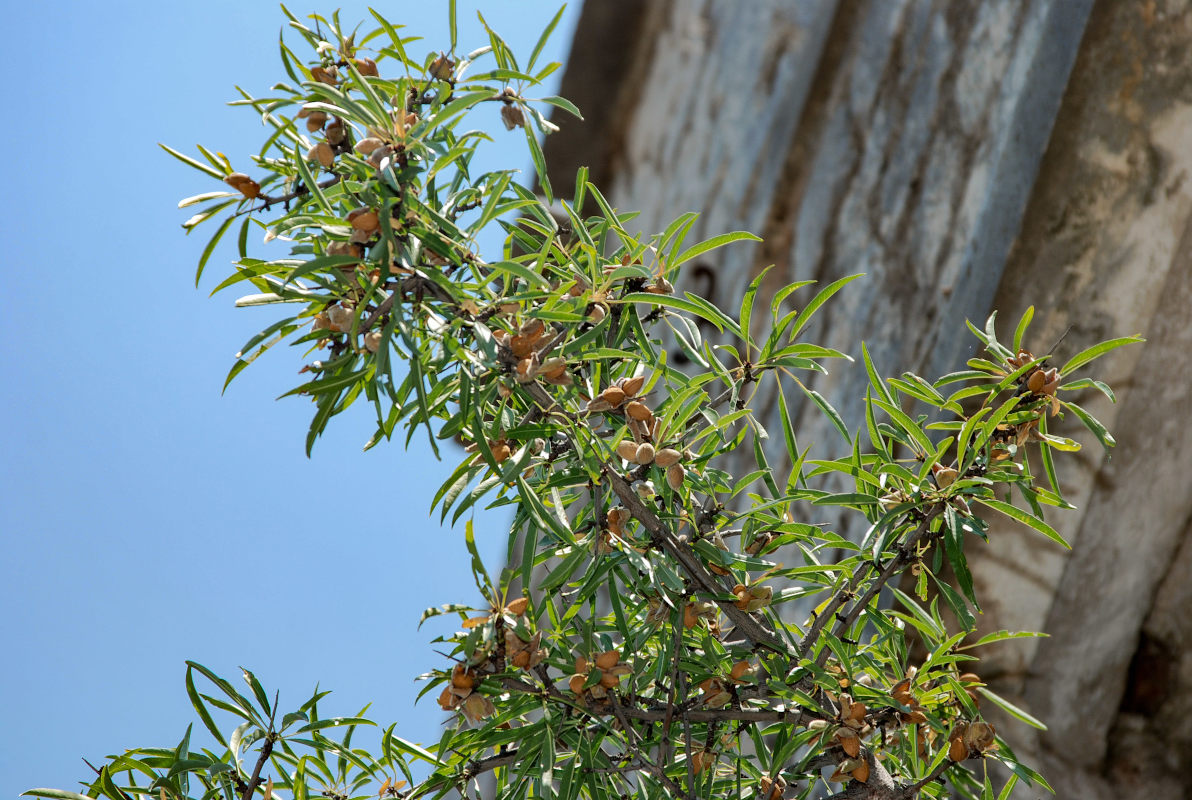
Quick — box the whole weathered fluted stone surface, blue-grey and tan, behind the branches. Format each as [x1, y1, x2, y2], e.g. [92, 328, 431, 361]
[545, 0, 1192, 798]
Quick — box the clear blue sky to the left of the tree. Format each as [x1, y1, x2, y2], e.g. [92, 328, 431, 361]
[0, 0, 579, 798]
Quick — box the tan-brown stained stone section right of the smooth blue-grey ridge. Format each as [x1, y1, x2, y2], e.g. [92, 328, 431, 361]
[974, 1, 1192, 798]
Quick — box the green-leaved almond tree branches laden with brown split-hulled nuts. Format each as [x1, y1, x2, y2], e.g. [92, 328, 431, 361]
[29, 6, 1138, 800]
